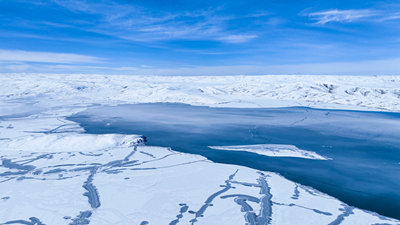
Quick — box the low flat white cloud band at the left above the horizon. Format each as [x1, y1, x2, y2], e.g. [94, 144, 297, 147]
[0, 49, 103, 64]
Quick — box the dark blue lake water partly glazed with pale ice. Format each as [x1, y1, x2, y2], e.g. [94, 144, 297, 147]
[68, 104, 400, 219]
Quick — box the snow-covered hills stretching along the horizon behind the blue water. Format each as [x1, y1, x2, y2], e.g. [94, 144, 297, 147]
[0, 74, 400, 111]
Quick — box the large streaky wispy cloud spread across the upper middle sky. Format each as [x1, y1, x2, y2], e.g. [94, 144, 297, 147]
[47, 0, 262, 43]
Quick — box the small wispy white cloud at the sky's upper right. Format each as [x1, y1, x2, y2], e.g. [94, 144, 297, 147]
[308, 9, 378, 24]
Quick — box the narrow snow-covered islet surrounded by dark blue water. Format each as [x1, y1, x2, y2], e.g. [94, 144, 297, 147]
[209, 144, 328, 160]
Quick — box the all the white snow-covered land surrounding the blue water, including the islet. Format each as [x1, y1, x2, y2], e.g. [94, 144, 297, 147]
[0, 74, 400, 225]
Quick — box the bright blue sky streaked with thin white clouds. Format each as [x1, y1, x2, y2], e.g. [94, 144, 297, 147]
[0, 0, 400, 76]
